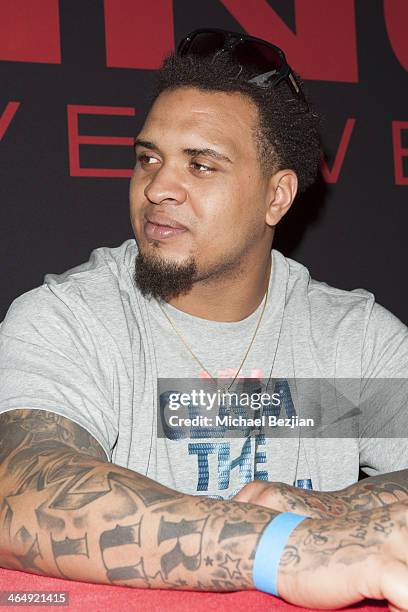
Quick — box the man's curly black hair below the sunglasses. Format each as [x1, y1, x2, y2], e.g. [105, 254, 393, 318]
[152, 53, 322, 193]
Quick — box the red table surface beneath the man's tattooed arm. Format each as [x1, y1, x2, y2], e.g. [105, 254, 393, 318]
[0, 568, 387, 612]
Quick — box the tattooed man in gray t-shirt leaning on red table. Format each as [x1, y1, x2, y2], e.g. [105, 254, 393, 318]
[0, 27, 408, 609]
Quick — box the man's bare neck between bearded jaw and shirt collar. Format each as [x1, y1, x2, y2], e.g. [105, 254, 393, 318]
[164, 253, 272, 322]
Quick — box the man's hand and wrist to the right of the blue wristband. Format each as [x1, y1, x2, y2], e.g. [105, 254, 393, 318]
[277, 502, 408, 611]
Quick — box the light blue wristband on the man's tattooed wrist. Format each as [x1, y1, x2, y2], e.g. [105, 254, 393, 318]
[252, 512, 310, 596]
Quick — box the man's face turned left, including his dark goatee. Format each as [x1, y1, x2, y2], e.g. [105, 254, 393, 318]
[130, 88, 272, 299]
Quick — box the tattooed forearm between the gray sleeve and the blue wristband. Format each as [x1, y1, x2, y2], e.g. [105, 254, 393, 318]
[0, 410, 277, 591]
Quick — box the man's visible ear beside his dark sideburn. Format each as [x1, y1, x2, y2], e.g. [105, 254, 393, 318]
[266, 170, 298, 227]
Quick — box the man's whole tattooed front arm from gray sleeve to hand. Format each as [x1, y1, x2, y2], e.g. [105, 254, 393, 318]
[0, 409, 408, 609]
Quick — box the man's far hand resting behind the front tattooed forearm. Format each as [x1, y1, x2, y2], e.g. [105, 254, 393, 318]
[233, 480, 348, 519]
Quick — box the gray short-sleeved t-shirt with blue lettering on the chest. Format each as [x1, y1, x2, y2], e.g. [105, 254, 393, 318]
[0, 240, 408, 498]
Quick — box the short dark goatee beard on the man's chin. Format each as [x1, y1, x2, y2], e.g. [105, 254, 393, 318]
[134, 251, 197, 302]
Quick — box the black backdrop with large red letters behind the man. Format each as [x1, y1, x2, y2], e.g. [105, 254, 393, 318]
[0, 0, 408, 323]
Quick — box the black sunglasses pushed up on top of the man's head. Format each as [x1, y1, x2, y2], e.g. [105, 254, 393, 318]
[177, 28, 306, 102]
